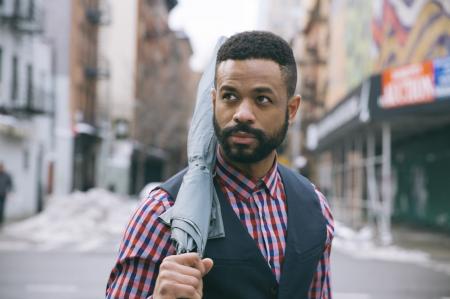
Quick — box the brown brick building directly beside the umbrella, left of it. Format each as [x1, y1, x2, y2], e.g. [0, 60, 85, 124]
[131, 0, 197, 193]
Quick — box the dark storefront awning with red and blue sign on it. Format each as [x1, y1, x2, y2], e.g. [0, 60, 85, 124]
[306, 57, 450, 151]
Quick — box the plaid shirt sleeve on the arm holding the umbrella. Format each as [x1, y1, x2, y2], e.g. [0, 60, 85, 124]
[106, 189, 175, 299]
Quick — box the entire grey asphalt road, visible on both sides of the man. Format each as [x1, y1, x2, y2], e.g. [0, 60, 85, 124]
[0, 250, 450, 299]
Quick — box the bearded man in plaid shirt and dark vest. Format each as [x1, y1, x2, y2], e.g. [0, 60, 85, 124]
[106, 31, 333, 299]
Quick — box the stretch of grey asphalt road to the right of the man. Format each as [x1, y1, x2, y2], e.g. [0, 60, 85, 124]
[332, 250, 450, 299]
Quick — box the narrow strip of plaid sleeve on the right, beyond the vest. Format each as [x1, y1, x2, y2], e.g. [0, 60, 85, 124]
[308, 188, 334, 299]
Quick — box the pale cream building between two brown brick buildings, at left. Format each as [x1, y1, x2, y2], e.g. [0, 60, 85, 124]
[96, 0, 138, 194]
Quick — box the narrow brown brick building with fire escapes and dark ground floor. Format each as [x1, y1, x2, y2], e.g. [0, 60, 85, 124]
[69, 0, 110, 191]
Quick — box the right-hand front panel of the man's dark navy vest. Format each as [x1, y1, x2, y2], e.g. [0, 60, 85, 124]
[278, 165, 326, 298]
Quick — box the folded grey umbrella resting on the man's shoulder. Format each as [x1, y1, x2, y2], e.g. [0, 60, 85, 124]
[160, 37, 226, 256]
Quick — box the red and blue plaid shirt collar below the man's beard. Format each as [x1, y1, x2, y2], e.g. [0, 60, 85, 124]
[215, 149, 281, 199]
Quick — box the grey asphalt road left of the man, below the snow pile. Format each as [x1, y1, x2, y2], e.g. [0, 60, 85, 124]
[0, 251, 115, 299]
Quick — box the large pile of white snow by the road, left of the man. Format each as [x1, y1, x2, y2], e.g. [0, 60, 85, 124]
[0, 189, 137, 251]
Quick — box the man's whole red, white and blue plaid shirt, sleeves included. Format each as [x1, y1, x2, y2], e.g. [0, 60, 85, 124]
[106, 154, 333, 299]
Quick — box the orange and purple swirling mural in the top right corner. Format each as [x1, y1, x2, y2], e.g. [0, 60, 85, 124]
[372, 0, 450, 72]
